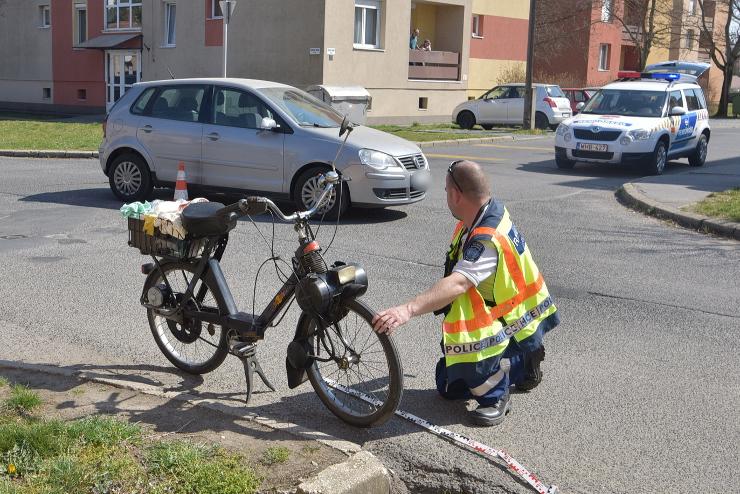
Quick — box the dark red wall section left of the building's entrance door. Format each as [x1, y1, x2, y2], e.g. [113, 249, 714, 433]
[51, 0, 105, 108]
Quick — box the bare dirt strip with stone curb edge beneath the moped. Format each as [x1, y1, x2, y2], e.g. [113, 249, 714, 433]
[0, 360, 392, 494]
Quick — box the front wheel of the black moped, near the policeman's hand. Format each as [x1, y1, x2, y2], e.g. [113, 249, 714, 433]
[305, 300, 403, 427]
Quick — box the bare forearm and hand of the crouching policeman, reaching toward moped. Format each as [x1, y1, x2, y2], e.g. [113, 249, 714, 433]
[373, 272, 474, 334]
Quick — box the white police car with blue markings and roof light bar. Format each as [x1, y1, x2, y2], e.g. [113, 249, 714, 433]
[555, 67, 710, 175]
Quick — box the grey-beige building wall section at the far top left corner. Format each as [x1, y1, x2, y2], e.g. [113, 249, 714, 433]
[0, 0, 54, 104]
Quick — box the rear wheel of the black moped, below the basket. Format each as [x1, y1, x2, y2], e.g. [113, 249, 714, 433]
[144, 262, 228, 374]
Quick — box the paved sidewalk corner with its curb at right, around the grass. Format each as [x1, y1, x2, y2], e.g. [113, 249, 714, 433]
[617, 163, 740, 240]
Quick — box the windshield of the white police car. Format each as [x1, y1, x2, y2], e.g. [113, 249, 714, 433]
[581, 89, 666, 117]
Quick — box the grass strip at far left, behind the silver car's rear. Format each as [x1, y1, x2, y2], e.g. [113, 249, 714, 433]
[0, 113, 103, 151]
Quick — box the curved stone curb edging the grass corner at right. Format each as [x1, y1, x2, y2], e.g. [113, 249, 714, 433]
[616, 183, 740, 240]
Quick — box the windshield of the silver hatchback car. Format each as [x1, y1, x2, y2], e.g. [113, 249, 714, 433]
[257, 87, 344, 127]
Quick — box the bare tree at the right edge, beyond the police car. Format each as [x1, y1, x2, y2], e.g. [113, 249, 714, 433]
[693, 0, 740, 117]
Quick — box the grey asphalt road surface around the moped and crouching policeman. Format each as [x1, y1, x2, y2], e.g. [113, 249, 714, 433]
[0, 129, 740, 493]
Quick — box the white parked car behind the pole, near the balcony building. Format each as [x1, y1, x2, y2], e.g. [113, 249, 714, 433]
[452, 83, 573, 130]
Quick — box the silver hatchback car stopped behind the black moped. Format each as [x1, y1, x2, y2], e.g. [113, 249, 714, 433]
[100, 78, 429, 216]
